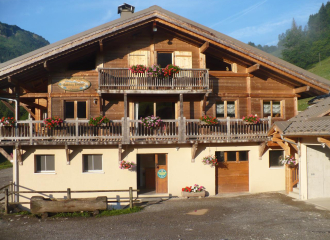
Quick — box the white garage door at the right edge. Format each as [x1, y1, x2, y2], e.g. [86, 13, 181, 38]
[307, 145, 330, 199]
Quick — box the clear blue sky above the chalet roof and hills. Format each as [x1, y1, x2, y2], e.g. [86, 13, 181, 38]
[0, 0, 327, 45]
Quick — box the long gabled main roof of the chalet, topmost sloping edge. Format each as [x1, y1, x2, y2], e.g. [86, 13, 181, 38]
[0, 6, 330, 91]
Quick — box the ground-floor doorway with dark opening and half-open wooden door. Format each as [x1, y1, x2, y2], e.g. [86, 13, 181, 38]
[137, 153, 168, 193]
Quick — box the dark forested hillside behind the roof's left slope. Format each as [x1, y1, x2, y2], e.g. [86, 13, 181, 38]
[0, 22, 49, 63]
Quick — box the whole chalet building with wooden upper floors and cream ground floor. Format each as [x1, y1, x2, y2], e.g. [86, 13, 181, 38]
[0, 4, 330, 206]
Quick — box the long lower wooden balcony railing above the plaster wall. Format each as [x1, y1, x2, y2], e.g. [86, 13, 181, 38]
[0, 118, 271, 145]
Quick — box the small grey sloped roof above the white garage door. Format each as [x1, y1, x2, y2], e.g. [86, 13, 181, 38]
[273, 98, 330, 136]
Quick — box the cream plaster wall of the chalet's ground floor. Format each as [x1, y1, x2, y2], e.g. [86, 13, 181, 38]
[14, 144, 285, 208]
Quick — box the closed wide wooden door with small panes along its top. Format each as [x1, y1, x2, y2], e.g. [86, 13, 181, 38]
[216, 151, 249, 193]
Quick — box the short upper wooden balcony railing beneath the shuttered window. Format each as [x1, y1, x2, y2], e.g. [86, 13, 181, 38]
[99, 68, 209, 91]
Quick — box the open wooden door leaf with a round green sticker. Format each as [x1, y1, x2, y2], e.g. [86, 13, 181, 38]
[155, 154, 168, 193]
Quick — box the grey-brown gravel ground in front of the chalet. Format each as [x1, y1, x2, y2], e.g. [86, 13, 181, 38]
[0, 193, 330, 240]
